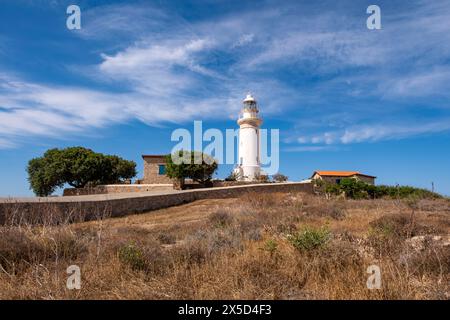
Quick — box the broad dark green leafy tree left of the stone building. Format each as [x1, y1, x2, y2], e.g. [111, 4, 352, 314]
[27, 147, 136, 196]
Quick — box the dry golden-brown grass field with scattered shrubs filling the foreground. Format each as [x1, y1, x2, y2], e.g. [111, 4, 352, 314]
[0, 193, 450, 299]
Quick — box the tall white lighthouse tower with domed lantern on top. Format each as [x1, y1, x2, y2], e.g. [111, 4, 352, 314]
[235, 94, 262, 181]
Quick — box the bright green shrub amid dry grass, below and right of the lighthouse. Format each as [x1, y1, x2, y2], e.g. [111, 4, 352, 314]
[288, 226, 331, 251]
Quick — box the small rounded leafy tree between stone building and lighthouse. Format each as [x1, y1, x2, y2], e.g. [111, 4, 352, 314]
[166, 150, 218, 185]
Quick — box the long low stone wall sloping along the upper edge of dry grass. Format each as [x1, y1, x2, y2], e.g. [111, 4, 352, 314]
[0, 183, 313, 224]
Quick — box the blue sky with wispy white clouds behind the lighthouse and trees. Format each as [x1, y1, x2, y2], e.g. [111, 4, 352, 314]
[0, 0, 450, 196]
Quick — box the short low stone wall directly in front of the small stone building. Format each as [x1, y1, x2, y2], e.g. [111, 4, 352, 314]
[63, 183, 173, 196]
